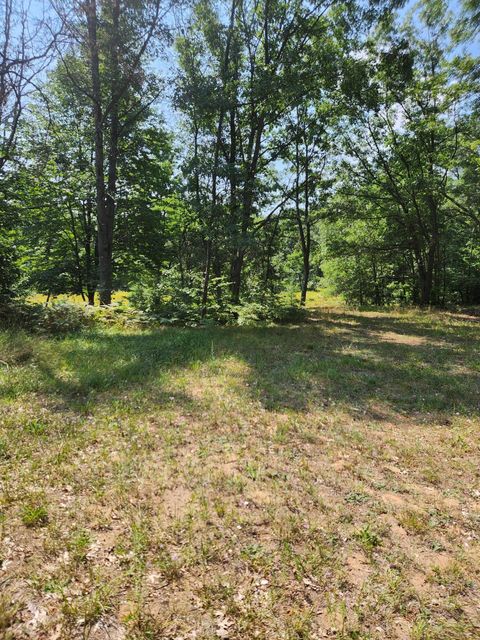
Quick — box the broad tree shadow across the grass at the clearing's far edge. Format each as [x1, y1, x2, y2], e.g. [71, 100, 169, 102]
[0, 311, 480, 419]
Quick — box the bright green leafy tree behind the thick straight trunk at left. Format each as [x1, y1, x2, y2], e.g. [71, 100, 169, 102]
[17, 63, 176, 304]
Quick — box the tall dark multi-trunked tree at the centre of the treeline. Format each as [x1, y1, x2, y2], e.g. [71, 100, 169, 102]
[177, 0, 344, 304]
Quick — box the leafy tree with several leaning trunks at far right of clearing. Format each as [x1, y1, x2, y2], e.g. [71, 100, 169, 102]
[332, 6, 465, 305]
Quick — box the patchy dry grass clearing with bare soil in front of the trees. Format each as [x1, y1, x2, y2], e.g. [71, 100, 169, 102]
[0, 299, 480, 640]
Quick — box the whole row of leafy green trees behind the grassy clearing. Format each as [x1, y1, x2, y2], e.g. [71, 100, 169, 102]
[0, 0, 480, 319]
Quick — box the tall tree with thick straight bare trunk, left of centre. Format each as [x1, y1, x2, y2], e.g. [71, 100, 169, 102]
[56, 0, 169, 304]
